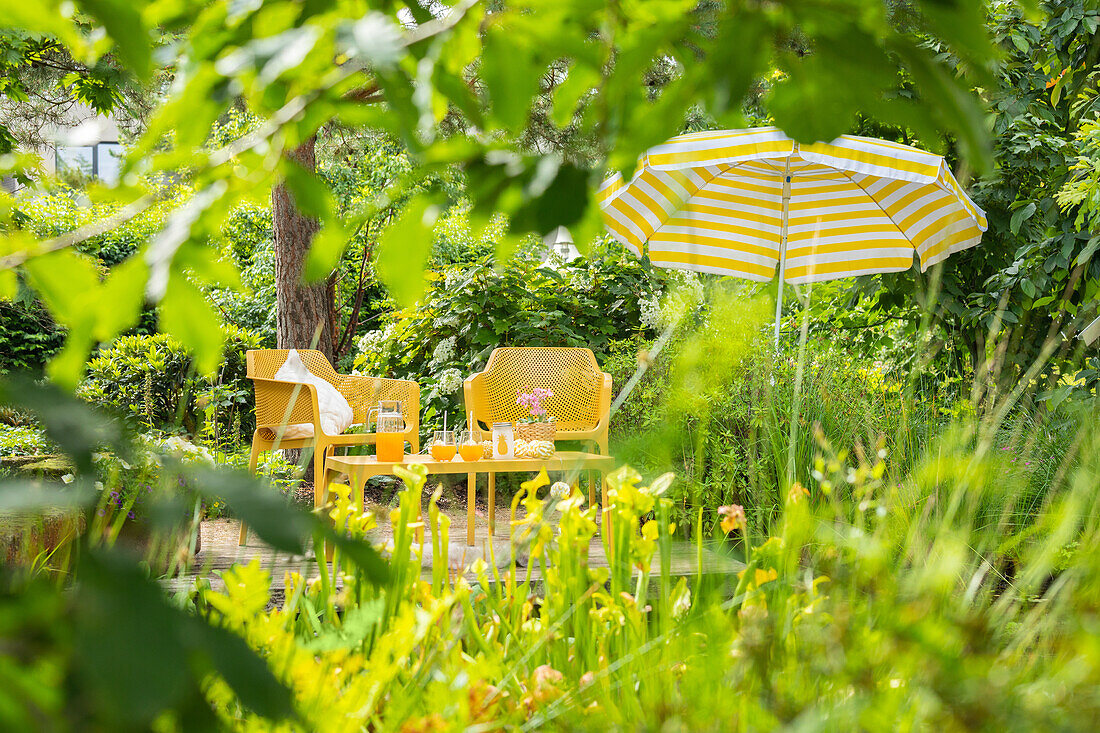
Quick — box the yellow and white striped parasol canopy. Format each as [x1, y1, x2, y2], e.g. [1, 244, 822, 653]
[597, 128, 987, 325]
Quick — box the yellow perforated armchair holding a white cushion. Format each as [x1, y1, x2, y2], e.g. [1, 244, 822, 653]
[240, 349, 420, 545]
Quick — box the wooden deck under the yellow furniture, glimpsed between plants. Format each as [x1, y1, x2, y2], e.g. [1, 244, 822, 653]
[164, 502, 744, 597]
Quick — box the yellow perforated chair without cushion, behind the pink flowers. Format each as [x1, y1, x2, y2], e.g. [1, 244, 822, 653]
[464, 347, 612, 456]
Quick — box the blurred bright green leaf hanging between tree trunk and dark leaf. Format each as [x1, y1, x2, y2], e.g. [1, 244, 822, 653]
[375, 195, 439, 308]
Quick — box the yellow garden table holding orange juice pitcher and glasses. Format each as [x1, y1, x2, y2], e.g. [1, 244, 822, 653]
[325, 451, 615, 547]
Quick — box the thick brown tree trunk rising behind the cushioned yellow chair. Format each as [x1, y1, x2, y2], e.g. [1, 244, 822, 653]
[272, 136, 336, 361]
